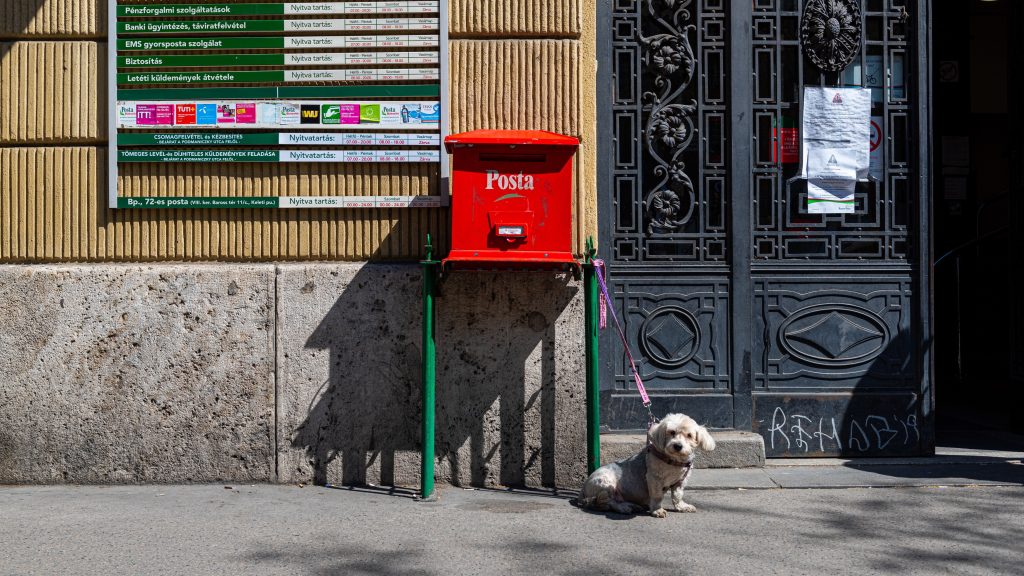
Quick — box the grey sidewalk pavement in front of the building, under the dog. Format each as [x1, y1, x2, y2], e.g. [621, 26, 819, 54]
[0, 479, 1024, 576]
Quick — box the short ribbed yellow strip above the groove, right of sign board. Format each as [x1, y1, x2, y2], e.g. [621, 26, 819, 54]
[449, 0, 584, 38]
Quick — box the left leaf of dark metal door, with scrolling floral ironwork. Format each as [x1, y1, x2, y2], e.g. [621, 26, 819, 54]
[599, 0, 733, 429]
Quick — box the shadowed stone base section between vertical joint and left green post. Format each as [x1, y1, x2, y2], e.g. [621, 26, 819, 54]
[276, 264, 422, 485]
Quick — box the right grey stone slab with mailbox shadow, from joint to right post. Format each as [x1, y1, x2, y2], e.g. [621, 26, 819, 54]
[278, 264, 586, 487]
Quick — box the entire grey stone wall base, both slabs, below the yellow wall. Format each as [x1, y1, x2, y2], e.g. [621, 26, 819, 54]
[0, 263, 586, 488]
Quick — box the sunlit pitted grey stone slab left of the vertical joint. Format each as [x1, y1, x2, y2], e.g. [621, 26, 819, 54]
[0, 264, 274, 483]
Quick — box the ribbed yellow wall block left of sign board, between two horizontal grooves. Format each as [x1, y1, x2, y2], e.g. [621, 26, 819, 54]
[0, 40, 106, 145]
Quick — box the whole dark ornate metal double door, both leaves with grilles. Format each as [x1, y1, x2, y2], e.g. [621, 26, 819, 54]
[599, 0, 931, 455]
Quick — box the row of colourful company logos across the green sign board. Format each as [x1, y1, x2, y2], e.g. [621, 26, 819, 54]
[117, 101, 440, 128]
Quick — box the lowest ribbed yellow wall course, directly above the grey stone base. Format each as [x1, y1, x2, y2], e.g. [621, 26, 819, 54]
[0, 147, 447, 262]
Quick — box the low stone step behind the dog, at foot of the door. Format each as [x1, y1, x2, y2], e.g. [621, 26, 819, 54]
[601, 430, 765, 468]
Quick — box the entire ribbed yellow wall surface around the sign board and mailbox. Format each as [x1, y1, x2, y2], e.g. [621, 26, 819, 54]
[0, 0, 597, 261]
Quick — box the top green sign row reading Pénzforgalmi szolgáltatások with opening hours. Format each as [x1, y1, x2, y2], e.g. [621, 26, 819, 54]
[118, 0, 438, 16]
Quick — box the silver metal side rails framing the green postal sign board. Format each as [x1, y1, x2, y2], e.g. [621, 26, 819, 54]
[106, 0, 452, 208]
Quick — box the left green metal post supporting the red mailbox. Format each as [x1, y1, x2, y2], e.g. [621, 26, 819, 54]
[420, 234, 437, 500]
